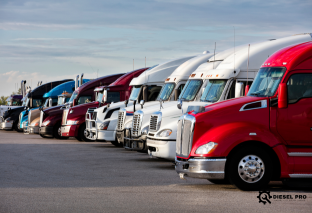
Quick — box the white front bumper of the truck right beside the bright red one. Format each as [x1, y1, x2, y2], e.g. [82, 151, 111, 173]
[146, 138, 176, 161]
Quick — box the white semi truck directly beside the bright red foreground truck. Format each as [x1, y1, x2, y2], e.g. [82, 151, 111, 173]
[146, 35, 311, 160]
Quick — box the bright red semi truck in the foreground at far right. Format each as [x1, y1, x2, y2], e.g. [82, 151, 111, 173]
[176, 42, 312, 190]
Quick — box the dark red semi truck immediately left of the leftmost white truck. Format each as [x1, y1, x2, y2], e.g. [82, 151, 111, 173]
[61, 68, 148, 141]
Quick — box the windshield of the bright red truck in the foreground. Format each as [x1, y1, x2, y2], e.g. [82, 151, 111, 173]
[248, 67, 285, 97]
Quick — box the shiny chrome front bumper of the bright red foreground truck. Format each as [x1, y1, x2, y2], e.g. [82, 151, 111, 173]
[175, 158, 226, 179]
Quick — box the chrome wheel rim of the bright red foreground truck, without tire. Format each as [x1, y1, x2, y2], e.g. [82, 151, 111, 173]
[238, 155, 265, 183]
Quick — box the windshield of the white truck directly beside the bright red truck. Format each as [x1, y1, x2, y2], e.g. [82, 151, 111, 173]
[200, 80, 227, 103]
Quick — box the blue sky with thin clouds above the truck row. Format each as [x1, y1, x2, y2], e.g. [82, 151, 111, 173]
[0, 0, 312, 95]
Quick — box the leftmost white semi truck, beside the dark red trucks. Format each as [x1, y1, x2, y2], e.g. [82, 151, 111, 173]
[86, 56, 194, 146]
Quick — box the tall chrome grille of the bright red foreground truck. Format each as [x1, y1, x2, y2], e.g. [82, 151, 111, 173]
[176, 115, 195, 157]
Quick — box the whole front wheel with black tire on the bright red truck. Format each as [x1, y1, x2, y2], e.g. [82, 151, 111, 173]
[227, 147, 273, 191]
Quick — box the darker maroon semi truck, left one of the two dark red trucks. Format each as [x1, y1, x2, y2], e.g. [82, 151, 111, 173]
[39, 74, 124, 139]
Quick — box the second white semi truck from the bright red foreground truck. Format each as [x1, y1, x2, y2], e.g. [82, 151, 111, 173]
[117, 47, 247, 152]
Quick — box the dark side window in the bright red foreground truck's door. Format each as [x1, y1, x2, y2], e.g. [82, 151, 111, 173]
[287, 74, 312, 104]
